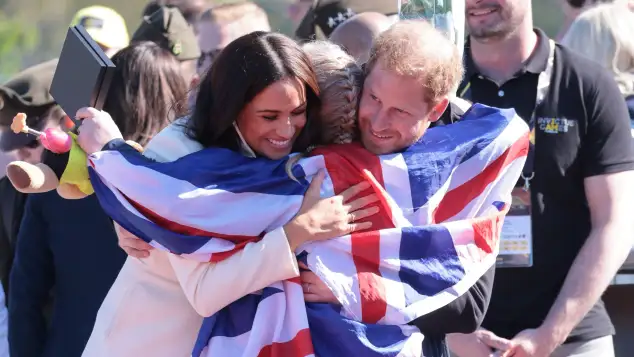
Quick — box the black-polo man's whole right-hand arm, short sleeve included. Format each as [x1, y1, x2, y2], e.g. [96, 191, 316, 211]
[519, 64, 634, 352]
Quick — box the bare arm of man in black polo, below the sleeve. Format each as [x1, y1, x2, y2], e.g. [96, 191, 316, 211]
[543, 171, 634, 343]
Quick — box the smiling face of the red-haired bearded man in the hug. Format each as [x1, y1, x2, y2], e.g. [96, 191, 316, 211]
[359, 63, 448, 155]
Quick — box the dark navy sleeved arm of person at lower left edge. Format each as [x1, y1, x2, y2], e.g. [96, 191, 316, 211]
[9, 195, 54, 357]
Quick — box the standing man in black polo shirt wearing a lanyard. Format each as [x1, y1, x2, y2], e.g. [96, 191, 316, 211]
[449, 0, 634, 357]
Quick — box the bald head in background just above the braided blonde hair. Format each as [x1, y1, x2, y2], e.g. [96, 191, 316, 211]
[329, 12, 394, 64]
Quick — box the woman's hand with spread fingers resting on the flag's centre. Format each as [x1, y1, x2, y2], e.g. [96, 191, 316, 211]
[284, 170, 379, 250]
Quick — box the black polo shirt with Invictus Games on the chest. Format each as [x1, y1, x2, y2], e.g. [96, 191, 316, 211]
[458, 30, 634, 342]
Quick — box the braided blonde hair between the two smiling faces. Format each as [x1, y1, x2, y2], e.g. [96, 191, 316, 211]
[303, 41, 363, 144]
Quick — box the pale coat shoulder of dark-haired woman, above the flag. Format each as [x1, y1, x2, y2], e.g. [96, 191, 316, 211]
[143, 117, 203, 161]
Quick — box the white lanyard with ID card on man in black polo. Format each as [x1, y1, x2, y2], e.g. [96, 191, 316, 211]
[460, 39, 555, 268]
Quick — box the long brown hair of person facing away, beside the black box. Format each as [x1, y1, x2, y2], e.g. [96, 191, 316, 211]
[104, 41, 187, 146]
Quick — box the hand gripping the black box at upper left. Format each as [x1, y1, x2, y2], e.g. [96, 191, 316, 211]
[75, 107, 123, 155]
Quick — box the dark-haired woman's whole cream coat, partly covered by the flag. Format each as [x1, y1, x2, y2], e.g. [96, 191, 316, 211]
[82, 122, 299, 357]
